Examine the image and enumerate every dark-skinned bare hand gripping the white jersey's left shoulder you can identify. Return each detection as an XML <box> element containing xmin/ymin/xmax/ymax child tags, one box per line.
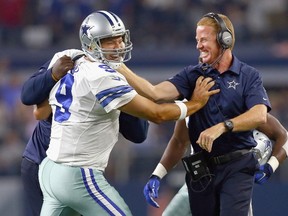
<box><xmin>52</xmin><ymin>55</ymin><xmax>74</xmax><ymax>80</ymax></box>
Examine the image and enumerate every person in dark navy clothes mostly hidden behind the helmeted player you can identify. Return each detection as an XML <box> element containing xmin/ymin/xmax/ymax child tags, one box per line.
<box><xmin>21</xmin><ymin>49</ymin><xmax>149</xmax><ymax>216</ymax></box>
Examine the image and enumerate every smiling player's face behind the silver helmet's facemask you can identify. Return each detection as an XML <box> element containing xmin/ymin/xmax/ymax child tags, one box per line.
<box><xmin>101</xmin><ymin>36</ymin><xmax>125</xmax><ymax>61</ymax></box>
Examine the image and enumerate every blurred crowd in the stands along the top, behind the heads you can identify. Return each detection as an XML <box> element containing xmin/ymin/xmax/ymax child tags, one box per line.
<box><xmin>0</xmin><ymin>0</ymin><xmax>288</xmax><ymax>48</ymax></box>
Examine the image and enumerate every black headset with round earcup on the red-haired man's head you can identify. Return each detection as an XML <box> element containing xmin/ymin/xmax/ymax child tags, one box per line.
<box><xmin>204</xmin><ymin>12</ymin><xmax>233</xmax><ymax>49</ymax></box>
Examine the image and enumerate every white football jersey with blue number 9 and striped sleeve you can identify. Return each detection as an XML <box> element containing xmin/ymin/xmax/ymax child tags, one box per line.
<box><xmin>47</xmin><ymin>52</ymin><xmax>137</xmax><ymax>170</ymax></box>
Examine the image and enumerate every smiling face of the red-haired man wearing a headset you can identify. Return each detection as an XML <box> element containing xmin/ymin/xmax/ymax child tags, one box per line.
<box><xmin>196</xmin><ymin>26</ymin><xmax>221</xmax><ymax>64</ymax></box>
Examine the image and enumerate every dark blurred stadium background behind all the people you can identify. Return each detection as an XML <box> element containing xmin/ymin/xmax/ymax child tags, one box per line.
<box><xmin>0</xmin><ymin>0</ymin><xmax>288</xmax><ymax>216</ymax></box>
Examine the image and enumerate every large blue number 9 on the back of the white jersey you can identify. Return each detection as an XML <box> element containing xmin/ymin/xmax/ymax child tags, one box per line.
<box><xmin>54</xmin><ymin>73</ymin><xmax>74</xmax><ymax>122</ymax></box>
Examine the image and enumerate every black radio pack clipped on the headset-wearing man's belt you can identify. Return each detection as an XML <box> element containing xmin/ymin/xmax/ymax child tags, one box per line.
<box><xmin>182</xmin><ymin>152</ymin><xmax>213</xmax><ymax>192</ymax></box>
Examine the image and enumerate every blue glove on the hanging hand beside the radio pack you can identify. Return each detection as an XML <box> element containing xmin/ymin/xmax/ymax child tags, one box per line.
<box><xmin>143</xmin><ymin>175</ymin><xmax>160</xmax><ymax>208</ymax></box>
